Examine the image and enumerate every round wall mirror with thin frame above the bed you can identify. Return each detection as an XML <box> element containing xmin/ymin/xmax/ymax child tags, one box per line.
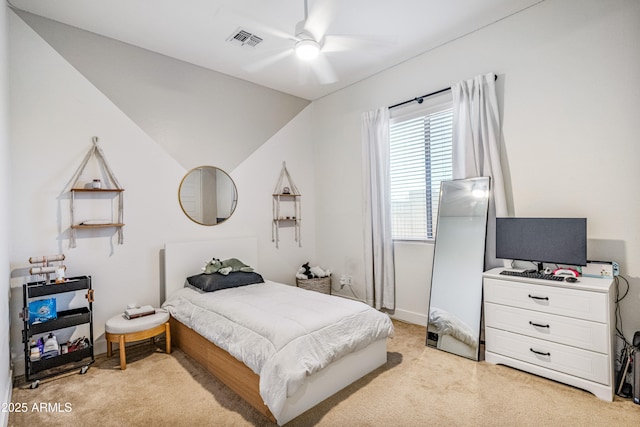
<box><xmin>178</xmin><ymin>166</ymin><xmax>238</xmax><ymax>225</ymax></box>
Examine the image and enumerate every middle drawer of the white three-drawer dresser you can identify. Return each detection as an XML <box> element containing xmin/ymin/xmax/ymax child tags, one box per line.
<box><xmin>484</xmin><ymin>303</ymin><xmax>610</xmax><ymax>354</ymax></box>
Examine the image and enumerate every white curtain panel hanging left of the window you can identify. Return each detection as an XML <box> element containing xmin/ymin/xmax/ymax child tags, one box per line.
<box><xmin>362</xmin><ymin>108</ymin><xmax>395</xmax><ymax>309</ymax></box>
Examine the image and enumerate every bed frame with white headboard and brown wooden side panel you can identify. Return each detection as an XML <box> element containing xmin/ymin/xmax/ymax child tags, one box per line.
<box><xmin>163</xmin><ymin>238</ymin><xmax>387</xmax><ymax>425</ymax></box>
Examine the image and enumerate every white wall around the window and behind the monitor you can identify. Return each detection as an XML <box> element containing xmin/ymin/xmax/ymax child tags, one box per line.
<box><xmin>312</xmin><ymin>0</ymin><xmax>640</xmax><ymax>348</ymax></box>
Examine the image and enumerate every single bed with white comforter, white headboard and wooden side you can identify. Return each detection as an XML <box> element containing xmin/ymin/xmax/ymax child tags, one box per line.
<box><xmin>163</xmin><ymin>237</ymin><xmax>393</xmax><ymax>425</ymax></box>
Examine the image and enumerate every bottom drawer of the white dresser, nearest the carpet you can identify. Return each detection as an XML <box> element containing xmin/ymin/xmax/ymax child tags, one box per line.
<box><xmin>485</xmin><ymin>328</ymin><xmax>611</xmax><ymax>385</ymax></box>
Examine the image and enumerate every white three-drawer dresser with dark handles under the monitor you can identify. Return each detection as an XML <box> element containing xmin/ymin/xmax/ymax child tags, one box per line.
<box><xmin>483</xmin><ymin>268</ymin><xmax>615</xmax><ymax>401</ymax></box>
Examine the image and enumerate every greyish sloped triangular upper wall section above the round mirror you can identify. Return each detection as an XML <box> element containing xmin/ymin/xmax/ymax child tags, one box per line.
<box><xmin>17</xmin><ymin>11</ymin><xmax>309</xmax><ymax>171</ymax></box>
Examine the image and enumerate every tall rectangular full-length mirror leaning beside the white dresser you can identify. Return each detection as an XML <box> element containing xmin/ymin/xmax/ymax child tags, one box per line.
<box><xmin>427</xmin><ymin>177</ymin><xmax>489</xmax><ymax>360</ymax></box>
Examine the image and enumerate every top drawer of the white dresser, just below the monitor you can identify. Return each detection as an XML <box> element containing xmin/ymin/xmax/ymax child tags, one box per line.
<box><xmin>484</xmin><ymin>278</ymin><xmax>609</xmax><ymax>323</ymax></box>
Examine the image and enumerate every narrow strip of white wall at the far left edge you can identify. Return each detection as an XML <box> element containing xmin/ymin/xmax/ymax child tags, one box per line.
<box><xmin>0</xmin><ymin>5</ymin><xmax>12</xmax><ymax>426</ymax></box>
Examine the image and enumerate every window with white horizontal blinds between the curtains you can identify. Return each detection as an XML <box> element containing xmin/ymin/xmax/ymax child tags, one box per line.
<box><xmin>389</xmin><ymin>103</ymin><xmax>453</xmax><ymax>240</ymax></box>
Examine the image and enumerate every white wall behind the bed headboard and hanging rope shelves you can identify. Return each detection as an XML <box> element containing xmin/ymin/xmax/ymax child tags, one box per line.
<box><xmin>8</xmin><ymin>12</ymin><xmax>315</xmax><ymax>375</ymax></box>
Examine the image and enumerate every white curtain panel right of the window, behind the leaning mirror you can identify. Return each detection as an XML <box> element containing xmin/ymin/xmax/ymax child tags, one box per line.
<box><xmin>451</xmin><ymin>73</ymin><xmax>507</xmax><ymax>269</ymax></box>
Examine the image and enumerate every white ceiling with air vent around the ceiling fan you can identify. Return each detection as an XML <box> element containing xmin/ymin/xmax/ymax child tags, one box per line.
<box><xmin>10</xmin><ymin>0</ymin><xmax>543</xmax><ymax>100</ymax></box>
